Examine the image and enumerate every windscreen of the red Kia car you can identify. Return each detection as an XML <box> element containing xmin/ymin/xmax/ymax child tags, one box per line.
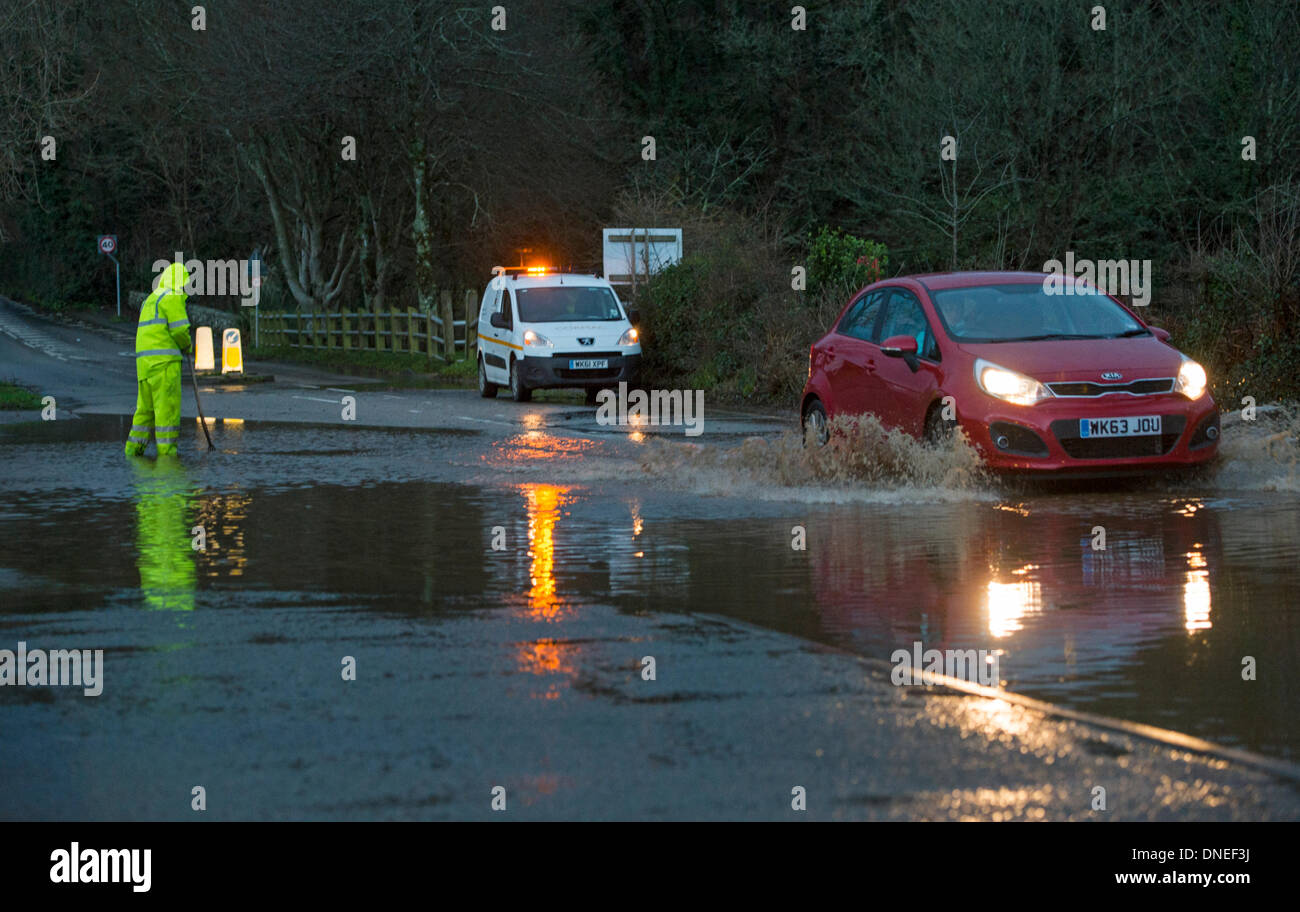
<box><xmin>931</xmin><ymin>282</ymin><xmax>1147</xmax><ymax>342</ymax></box>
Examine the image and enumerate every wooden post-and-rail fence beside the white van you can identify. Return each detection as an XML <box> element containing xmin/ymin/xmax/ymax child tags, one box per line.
<box><xmin>260</xmin><ymin>291</ymin><xmax>478</xmax><ymax>362</ymax></box>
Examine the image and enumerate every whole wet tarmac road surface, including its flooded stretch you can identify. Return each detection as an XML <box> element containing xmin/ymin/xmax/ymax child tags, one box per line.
<box><xmin>0</xmin><ymin>300</ymin><xmax>1300</xmax><ymax>820</ymax></box>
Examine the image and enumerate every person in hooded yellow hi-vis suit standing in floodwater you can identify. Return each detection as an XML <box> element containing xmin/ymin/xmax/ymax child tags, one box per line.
<box><xmin>126</xmin><ymin>262</ymin><xmax>190</xmax><ymax>456</ymax></box>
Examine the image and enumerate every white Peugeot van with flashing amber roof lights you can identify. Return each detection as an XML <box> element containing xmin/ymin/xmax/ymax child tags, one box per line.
<box><xmin>478</xmin><ymin>268</ymin><xmax>641</xmax><ymax>403</ymax></box>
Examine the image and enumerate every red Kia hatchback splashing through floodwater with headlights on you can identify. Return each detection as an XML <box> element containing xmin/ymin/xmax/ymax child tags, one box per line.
<box><xmin>800</xmin><ymin>273</ymin><xmax>1219</xmax><ymax>475</ymax></box>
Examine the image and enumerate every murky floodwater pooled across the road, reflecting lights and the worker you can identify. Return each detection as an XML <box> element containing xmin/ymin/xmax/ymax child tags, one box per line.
<box><xmin>0</xmin><ymin>417</ymin><xmax>1300</xmax><ymax>774</ymax></box>
